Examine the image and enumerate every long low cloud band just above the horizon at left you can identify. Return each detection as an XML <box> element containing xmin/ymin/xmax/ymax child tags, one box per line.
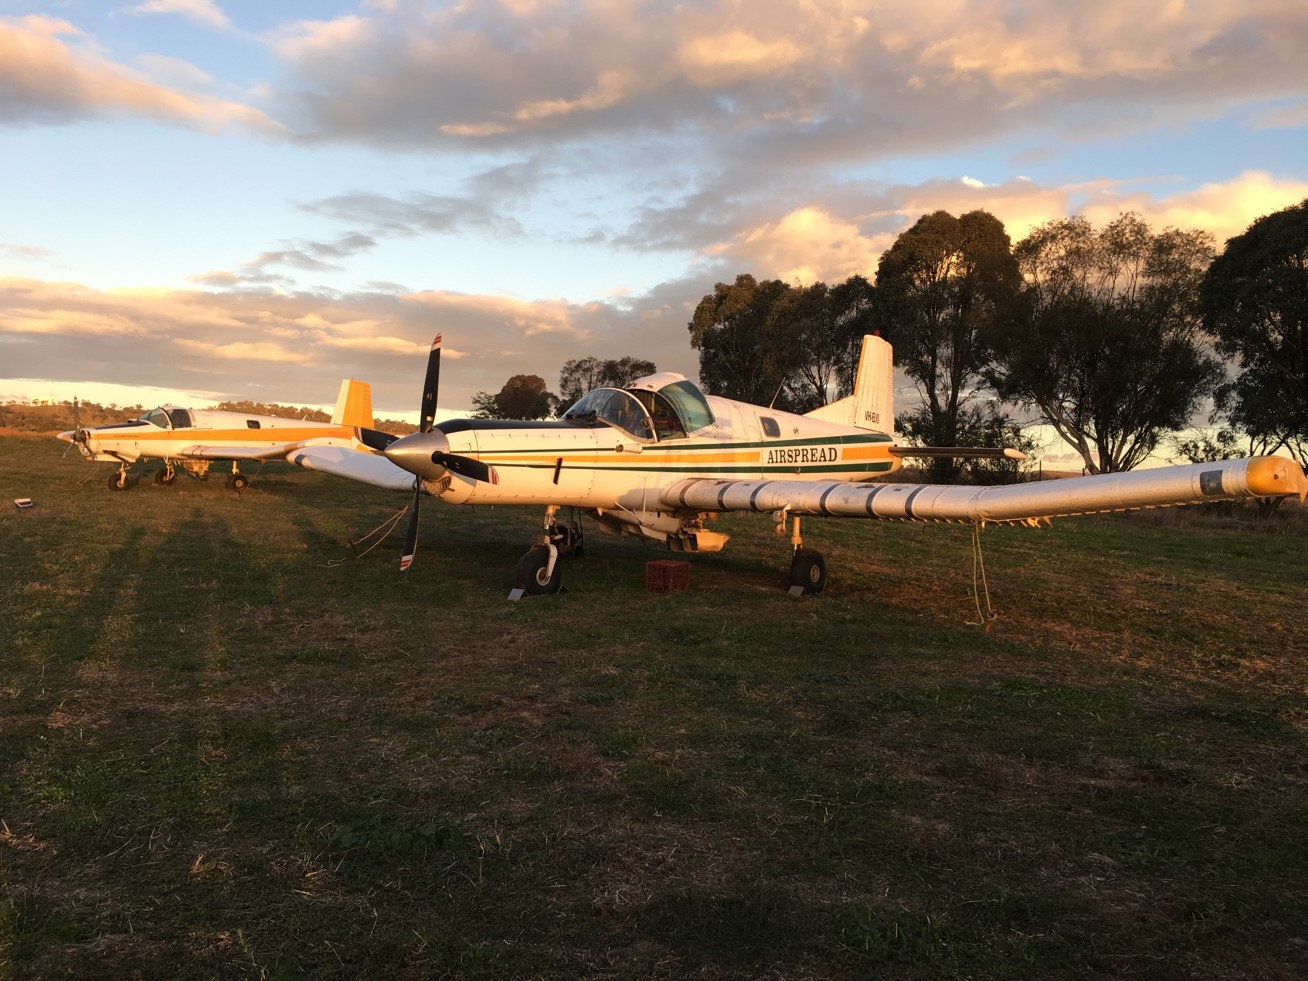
<box><xmin>0</xmin><ymin>277</ymin><xmax>664</xmax><ymax>413</ymax></box>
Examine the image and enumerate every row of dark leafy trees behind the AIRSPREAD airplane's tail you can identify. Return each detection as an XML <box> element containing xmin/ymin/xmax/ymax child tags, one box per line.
<box><xmin>688</xmin><ymin>201</ymin><xmax>1308</xmax><ymax>480</ymax></box>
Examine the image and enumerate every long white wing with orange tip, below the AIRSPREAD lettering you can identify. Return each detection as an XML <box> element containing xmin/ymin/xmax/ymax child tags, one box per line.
<box><xmin>659</xmin><ymin>456</ymin><xmax>1308</xmax><ymax>525</ymax></box>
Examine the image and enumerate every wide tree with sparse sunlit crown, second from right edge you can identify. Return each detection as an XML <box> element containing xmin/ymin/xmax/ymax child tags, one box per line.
<box><xmin>988</xmin><ymin>213</ymin><xmax>1222</xmax><ymax>473</ymax></box>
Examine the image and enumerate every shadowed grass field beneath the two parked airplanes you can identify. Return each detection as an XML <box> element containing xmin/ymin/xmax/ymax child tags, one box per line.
<box><xmin>0</xmin><ymin>437</ymin><xmax>1308</xmax><ymax>978</ymax></box>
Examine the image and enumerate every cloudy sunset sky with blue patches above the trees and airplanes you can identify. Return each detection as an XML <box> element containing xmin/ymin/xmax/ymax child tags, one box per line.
<box><xmin>0</xmin><ymin>0</ymin><xmax>1308</xmax><ymax>449</ymax></box>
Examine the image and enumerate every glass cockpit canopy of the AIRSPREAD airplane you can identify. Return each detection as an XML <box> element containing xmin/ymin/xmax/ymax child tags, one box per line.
<box><xmin>562</xmin><ymin>371</ymin><xmax>713</xmax><ymax>439</ymax></box>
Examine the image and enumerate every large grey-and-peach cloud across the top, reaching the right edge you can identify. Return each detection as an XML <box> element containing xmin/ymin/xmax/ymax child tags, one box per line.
<box><xmin>262</xmin><ymin>0</ymin><xmax>1308</xmax><ymax>162</ymax></box>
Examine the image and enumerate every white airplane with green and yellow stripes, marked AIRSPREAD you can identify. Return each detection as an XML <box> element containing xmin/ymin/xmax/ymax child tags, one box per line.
<box><xmin>289</xmin><ymin>335</ymin><xmax>1308</xmax><ymax>594</ymax></box>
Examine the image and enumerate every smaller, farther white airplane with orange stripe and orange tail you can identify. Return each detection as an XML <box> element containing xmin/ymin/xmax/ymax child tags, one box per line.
<box><xmin>59</xmin><ymin>378</ymin><xmax>387</xmax><ymax>491</ymax></box>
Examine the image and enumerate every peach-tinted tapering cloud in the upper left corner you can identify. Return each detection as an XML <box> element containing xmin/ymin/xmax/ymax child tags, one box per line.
<box><xmin>0</xmin><ymin>14</ymin><xmax>284</xmax><ymax>136</ymax></box>
